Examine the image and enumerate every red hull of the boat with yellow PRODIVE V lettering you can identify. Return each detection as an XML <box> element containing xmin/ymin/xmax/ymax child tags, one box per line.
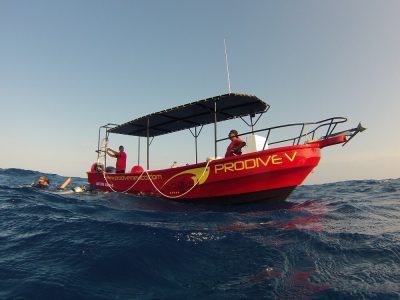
<box><xmin>88</xmin><ymin>142</ymin><xmax>322</xmax><ymax>204</ymax></box>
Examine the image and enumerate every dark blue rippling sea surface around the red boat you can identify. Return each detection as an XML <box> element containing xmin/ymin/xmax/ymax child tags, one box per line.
<box><xmin>0</xmin><ymin>169</ymin><xmax>400</xmax><ymax>299</ymax></box>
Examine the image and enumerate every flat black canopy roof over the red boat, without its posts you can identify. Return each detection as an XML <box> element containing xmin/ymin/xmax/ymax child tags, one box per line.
<box><xmin>110</xmin><ymin>94</ymin><xmax>269</xmax><ymax>137</ymax></box>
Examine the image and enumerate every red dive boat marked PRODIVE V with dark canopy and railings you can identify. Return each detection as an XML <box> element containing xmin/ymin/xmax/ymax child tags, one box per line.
<box><xmin>87</xmin><ymin>94</ymin><xmax>365</xmax><ymax>204</ymax></box>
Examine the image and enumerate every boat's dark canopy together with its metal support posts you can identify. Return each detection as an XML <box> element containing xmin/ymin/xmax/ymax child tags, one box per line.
<box><xmin>96</xmin><ymin>94</ymin><xmax>270</xmax><ymax>169</ymax></box>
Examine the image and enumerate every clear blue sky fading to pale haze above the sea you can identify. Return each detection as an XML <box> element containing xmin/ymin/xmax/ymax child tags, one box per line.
<box><xmin>0</xmin><ymin>0</ymin><xmax>400</xmax><ymax>184</ymax></box>
